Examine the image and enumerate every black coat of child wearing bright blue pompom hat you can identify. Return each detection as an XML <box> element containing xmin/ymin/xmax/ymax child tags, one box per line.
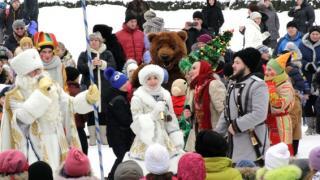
<box><xmin>105</xmin><ymin>88</ymin><xmax>134</xmax><ymax>147</ymax></box>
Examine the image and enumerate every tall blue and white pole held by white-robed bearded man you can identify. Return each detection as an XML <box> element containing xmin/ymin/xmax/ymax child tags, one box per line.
<box><xmin>81</xmin><ymin>0</ymin><xmax>104</xmax><ymax>179</ymax></box>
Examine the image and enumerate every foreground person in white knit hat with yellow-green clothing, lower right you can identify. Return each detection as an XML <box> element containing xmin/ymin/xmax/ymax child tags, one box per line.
<box><xmin>256</xmin><ymin>143</ymin><xmax>302</xmax><ymax>180</ymax></box>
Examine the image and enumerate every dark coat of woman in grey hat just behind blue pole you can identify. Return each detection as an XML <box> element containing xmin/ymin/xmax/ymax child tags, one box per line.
<box><xmin>77</xmin><ymin>50</ymin><xmax>116</xmax><ymax>110</ymax></box>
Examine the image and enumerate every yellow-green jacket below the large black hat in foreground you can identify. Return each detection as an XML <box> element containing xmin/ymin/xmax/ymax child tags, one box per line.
<box><xmin>204</xmin><ymin>157</ymin><xmax>242</xmax><ymax>180</ymax></box>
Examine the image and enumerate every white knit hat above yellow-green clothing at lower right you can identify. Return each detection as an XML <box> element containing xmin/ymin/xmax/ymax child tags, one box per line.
<box><xmin>265</xmin><ymin>142</ymin><xmax>290</xmax><ymax>170</ymax></box>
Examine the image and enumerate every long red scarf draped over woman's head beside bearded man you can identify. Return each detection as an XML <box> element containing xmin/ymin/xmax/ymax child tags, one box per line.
<box><xmin>190</xmin><ymin>61</ymin><xmax>215</xmax><ymax>129</ymax></box>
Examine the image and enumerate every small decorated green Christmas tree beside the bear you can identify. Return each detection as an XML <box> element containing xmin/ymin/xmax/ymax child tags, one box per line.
<box><xmin>179</xmin><ymin>30</ymin><xmax>233</xmax><ymax>72</ymax></box>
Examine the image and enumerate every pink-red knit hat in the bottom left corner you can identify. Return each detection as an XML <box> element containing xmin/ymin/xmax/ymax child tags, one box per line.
<box><xmin>0</xmin><ymin>150</ymin><xmax>29</xmax><ymax>174</ymax></box>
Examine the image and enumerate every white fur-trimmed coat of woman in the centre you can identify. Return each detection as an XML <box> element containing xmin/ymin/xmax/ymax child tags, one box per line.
<box><xmin>130</xmin><ymin>87</ymin><xmax>184</xmax><ymax>159</ymax></box>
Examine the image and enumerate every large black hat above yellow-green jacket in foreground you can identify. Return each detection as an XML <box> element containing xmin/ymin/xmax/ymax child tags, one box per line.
<box><xmin>195</xmin><ymin>130</ymin><xmax>228</xmax><ymax>158</ymax></box>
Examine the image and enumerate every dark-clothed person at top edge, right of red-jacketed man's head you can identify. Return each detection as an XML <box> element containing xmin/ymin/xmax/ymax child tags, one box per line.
<box><xmin>125</xmin><ymin>0</ymin><xmax>150</xmax><ymax>31</ymax></box>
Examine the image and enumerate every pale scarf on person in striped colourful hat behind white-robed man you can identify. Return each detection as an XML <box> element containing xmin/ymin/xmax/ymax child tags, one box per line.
<box><xmin>43</xmin><ymin>56</ymin><xmax>64</xmax><ymax>88</ymax></box>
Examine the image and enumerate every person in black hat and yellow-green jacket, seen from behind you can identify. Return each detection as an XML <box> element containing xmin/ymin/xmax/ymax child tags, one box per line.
<box><xmin>195</xmin><ymin>130</ymin><xmax>242</xmax><ymax>180</ymax></box>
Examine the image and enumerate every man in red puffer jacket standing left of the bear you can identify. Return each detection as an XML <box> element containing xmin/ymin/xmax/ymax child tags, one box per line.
<box><xmin>116</xmin><ymin>14</ymin><xmax>145</xmax><ymax>65</ymax></box>
